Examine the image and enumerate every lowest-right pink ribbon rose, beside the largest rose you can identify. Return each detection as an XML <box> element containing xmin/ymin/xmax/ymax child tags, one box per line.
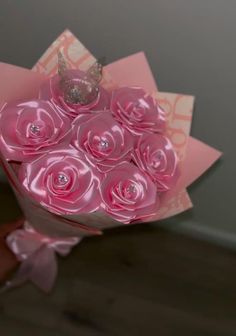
<box><xmin>100</xmin><ymin>162</ymin><xmax>159</xmax><ymax>224</ymax></box>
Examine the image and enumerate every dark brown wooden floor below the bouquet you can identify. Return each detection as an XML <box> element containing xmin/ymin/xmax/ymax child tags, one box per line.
<box><xmin>0</xmin><ymin>182</ymin><xmax>236</xmax><ymax>336</ymax></box>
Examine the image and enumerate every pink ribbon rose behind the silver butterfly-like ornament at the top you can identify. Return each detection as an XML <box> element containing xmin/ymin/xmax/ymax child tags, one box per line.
<box><xmin>39</xmin><ymin>70</ymin><xmax>110</xmax><ymax>118</ymax></box>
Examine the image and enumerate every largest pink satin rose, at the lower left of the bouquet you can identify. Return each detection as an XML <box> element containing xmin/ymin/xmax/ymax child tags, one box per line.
<box><xmin>19</xmin><ymin>147</ymin><xmax>101</xmax><ymax>214</ymax></box>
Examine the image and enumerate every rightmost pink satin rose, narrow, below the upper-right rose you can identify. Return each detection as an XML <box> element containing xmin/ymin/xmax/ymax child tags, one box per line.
<box><xmin>132</xmin><ymin>134</ymin><xmax>179</xmax><ymax>192</ymax></box>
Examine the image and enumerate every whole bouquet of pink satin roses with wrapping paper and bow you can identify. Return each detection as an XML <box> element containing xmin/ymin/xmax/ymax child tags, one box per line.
<box><xmin>0</xmin><ymin>31</ymin><xmax>221</xmax><ymax>291</ymax></box>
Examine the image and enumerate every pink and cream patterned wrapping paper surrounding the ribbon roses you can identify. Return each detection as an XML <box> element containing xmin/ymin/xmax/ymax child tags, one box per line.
<box><xmin>0</xmin><ymin>30</ymin><xmax>221</xmax><ymax>284</ymax></box>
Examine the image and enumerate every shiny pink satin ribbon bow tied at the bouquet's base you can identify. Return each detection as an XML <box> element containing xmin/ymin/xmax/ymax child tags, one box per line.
<box><xmin>2</xmin><ymin>222</ymin><xmax>82</xmax><ymax>292</ymax></box>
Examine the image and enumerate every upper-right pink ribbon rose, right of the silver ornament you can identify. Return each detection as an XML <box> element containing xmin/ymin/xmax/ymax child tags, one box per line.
<box><xmin>111</xmin><ymin>87</ymin><xmax>165</xmax><ymax>134</ymax></box>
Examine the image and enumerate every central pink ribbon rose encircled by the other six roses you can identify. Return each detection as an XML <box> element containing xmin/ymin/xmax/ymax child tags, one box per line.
<box><xmin>72</xmin><ymin>112</ymin><xmax>133</xmax><ymax>172</ymax></box>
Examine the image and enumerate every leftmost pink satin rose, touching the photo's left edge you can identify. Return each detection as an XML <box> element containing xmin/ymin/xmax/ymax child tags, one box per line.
<box><xmin>0</xmin><ymin>100</ymin><xmax>71</xmax><ymax>162</ymax></box>
